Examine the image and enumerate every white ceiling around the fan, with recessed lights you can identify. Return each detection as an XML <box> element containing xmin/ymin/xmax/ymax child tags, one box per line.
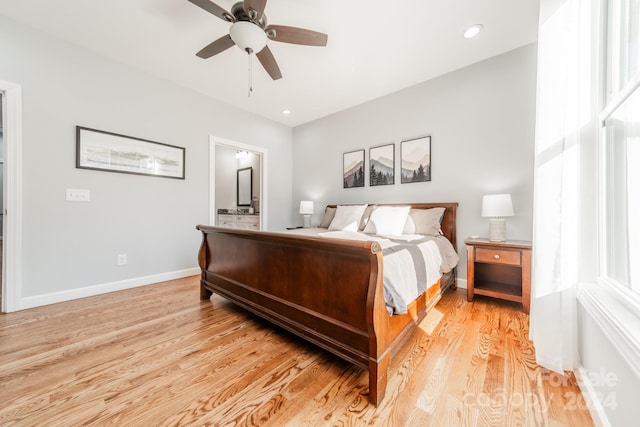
<box><xmin>0</xmin><ymin>0</ymin><xmax>538</xmax><ymax>126</ymax></box>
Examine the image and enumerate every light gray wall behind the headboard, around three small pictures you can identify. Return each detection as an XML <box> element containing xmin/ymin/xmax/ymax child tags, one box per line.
<box><xmin>293</xmin><ymin>45</ymin><xmax>536</xmax><ymax>285</ymax></box>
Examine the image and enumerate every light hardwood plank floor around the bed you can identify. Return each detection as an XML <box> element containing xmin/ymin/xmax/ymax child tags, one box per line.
<box><xmin>0</xmin><ymin>277</ymin><xmax>593</xmax><ymax>426</ymax></box>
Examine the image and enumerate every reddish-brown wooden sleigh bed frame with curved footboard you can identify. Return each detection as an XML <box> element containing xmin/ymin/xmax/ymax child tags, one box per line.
<box><xmin>196</xmin><ymin>203</ymin><xmax>458</xmax><ymax>405</ymax></box>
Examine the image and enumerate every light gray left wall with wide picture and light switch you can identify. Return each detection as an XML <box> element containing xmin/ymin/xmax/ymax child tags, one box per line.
<box><xmin>0</xmin><ymin>17</ymin><xmax>292</xmax><ymax>297</ymax></box>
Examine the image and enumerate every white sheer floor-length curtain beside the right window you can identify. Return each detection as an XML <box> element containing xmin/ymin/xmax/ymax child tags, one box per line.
<box><xmin>530</xmin><ymin>0</ymin><xmax>596</xmax><ymax>373</ymax></box>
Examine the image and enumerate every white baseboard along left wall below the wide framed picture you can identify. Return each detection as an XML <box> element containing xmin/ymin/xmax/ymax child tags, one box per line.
<box><xmin>20</xmin><ymin>267</ymin><xmax>200</xmax><ymax>310</ymax></box>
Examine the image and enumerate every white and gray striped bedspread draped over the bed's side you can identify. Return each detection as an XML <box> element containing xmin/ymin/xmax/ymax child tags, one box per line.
<box><xmin>293</xmin><ymin>228</ymin><xmax>459</xmax><ymax>314</ymax></box>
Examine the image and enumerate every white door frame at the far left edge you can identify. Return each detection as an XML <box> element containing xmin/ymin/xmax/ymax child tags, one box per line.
<box><xmin>0</xmin><ymin>80</ymin><xmax>22</xmax><ymax>313</ymax></box>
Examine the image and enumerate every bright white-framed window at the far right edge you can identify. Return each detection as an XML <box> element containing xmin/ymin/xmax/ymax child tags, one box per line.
<box><xmin>600</xmin><ymin>0</ymin><xmax>640</xmax><ymax>294</ymax></box>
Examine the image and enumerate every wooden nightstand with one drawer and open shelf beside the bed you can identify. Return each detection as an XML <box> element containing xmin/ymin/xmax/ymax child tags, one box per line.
<box><xmin>464</xmin><ymin>239</ymin><xmax>531</xmax><ymax>314</ymax></box>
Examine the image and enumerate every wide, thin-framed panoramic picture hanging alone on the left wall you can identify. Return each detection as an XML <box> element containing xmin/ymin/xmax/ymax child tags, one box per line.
<box><xmin>76</xmin><ymin>126</ymin><xmax>185</xmax><ymax>179</ymax></box>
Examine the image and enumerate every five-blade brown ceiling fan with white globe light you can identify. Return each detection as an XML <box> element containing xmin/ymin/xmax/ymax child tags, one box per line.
<box><xmin>189</xmin><ymin>0</ymin><xmax>327</xmax><ymax>80</ymax></box>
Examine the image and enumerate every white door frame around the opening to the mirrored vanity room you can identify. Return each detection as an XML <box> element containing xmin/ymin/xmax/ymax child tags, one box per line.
<box><xmin>209</xmin><ymin>135</ymin><xmax>269</xmax><ymax>230</ymax></box>
